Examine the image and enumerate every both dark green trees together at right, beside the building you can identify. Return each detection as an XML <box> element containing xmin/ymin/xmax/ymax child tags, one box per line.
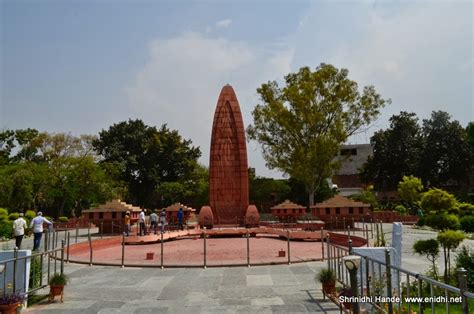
<box><xmin>361</xmin><ymin>111</ymin><xmax>474</xmax><ymax>191</ymax></box>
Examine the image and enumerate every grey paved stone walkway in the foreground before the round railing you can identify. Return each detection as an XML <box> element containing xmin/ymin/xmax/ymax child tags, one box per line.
<box><xmin>24</xmin><ymin>262</ymin><xmax>339</xmax><ymax>313</ymax></box>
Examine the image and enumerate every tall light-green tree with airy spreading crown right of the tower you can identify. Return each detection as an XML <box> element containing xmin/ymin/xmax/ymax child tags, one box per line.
<box><xmin>247</xmin><ymin>64</ymin><xmax>387</xmax><ymax>205</ymax></box>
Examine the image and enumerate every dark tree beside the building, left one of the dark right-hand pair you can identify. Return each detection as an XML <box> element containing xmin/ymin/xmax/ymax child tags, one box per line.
<box><xmin>362</xmin><ymin>111</ymin><xmax>423</xmax><ymax>191</ymax></box>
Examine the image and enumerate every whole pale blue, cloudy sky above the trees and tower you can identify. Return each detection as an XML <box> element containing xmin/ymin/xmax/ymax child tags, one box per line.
<box><xmin>0</xmin><ymin>0</ymin><xmax>474</xmax><ymax>177</ymax></box>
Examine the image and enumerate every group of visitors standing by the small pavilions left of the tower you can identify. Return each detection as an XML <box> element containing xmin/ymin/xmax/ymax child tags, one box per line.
<box><xmin>132</xmin><ymin>208</ymin><xmax>184</xmax><ymax>236</ymax></box>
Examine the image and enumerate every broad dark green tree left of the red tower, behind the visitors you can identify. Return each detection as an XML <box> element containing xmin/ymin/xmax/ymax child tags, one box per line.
<box><xmin>93</xmin><ymin>120</ymin><xmax>201</xmax><ymax>207</ymax></box>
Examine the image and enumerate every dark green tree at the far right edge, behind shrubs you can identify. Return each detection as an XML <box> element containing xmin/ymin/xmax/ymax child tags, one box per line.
<box><xmin>420</xmin><ymin>111</ymin><xmax>474</xmax><ymax>187</ymax></box>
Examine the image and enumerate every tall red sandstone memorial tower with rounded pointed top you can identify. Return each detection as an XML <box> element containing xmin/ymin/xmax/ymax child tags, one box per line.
<box><xmin>209</xmin><ymin>85</ymin><xmax>249</xmax><ymax>224</ymax></box>
